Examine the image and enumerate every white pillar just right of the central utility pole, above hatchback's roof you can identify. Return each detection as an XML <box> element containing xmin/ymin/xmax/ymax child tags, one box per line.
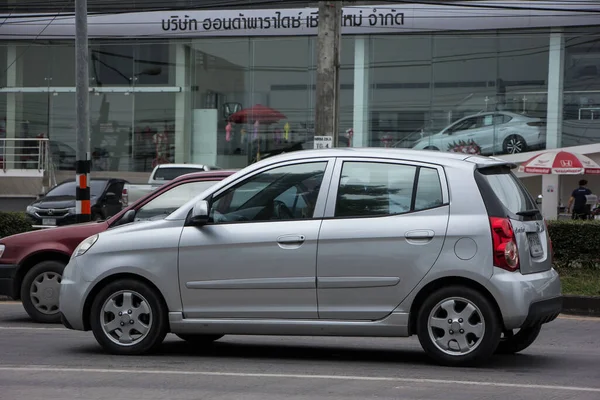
<box><xmin>352</xmin><ymin>36</ymin><xmax>371</xmax><ymax>147</ymax></box>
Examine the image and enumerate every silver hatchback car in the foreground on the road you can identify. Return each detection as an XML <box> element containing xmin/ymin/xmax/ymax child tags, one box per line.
<box><xmin>60</xmin><ymin>148</ymin><xmax>562</xmax><ymax>365</ymax></box>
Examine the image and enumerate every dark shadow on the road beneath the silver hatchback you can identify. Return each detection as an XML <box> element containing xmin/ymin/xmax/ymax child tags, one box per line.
<box><xmin>68</xmin><ymin>336</ymin><xmax>562</xmax><ymax>371</ymax></box>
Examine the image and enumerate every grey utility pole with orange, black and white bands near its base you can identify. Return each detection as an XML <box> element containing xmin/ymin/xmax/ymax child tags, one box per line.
<box><xmin>75</xmin><ymin>0</ymin><xmax>92</xmax><ymax>223</ymax></box>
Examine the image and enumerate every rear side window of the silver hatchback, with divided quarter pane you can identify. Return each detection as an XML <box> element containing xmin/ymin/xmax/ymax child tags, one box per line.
<box><xmin>335</xmin><ymin>162</ymin><xmax>443</xmax><ymax>218</ymax></box>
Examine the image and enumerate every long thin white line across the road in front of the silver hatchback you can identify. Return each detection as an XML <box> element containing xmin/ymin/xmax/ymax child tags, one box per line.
<box><xmin>0</xmin><ymin>366</ymin><xmax>600</xmax><ymax>393</ymax></box>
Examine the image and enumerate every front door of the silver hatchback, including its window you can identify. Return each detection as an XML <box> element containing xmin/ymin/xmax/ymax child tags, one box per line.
<box><xmin>179</xmin><ymin>159</ymin><xmax>333</xmax><ymax>319</ymax></box>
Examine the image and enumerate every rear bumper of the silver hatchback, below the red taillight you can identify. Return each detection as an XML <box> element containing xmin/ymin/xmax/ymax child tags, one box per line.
<box><xmin>488</xmin><ymin>269</ymin><xmax>562</xmax><ymax>329</ymax></box>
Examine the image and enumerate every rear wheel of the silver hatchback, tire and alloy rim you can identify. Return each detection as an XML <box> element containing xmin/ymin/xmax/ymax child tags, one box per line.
<box><xmin>417</xmin><ymin>286</ymin><xmax>501</xmax><ymax>366</ymax></box>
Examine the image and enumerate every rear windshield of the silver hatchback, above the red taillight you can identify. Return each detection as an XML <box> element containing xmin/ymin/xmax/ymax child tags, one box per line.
<box><xmin>479</xmin><ymin>168</ymin><xmax>537</xmax><ymax>214</ymax></box>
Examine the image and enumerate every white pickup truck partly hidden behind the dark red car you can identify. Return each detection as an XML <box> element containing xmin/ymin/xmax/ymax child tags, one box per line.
<box><xmin>122</xmin><ymin>164</ymin><xmax>221</xmax><ymax>206</ymax></box>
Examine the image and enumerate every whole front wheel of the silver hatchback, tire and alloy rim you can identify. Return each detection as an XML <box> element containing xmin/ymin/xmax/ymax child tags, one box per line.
<box><xmin>90</xmin><ymin>279</ymin><xmax>168</xmax><ymax>355</ymax></box>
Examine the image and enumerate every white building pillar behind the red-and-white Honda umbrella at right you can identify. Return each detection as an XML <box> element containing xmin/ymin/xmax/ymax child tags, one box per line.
<box><xmin>542</xmin><ymin>28</ymin><xmax>565</xmax><ymax>219</ymax></box>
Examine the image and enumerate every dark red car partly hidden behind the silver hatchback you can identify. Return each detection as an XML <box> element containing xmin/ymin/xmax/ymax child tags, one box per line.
<box><xmin>0</xmin><ymin>170</ymin><xmax>233</xmax><ymax>323</ymax></box>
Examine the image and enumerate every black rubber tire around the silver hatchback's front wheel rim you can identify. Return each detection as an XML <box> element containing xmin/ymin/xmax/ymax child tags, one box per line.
<box><xmin>90</xmin><ymin>279</ymin><xmax>169</xmax><ymax>355</ymax></box>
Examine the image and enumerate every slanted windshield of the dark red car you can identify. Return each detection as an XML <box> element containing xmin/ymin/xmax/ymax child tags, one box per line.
<box><xmin>135</xmin><ymin>181</ymin><xmax>218</xmax><ymax>221</ymax></box>
